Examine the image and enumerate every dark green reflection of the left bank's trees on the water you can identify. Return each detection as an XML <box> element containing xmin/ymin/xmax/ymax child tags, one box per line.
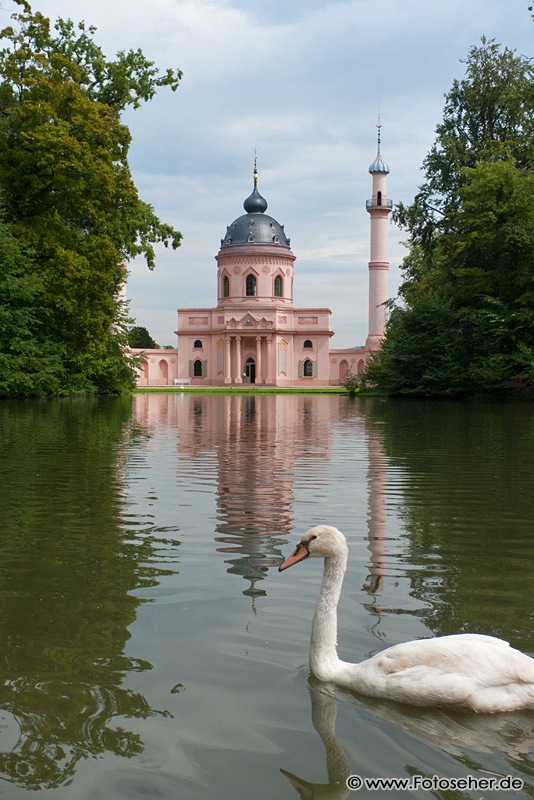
<box><xmin>0</xmin><ymin>398</ymin><xmax>170</xmax><ymax>789</ymax></box>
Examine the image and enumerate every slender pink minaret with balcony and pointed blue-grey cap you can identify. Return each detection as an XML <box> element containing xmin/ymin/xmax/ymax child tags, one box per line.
<box><xmin>365</xmin><ymin>118</ymin><xmax>393</xmax><ymax>350</ymax></box>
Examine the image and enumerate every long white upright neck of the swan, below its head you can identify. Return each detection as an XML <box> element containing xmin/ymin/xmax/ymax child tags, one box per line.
<box><xmin>310</xmin><ymin>553</ymin><xmax>347</xmax><ymax>681</ymax></box>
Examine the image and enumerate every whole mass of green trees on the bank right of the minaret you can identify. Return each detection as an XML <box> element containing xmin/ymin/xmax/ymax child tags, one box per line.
<box><xmin>365</xmin><ymin>39</ymin><xmax>534</xmax><ymax>396</ymax></box>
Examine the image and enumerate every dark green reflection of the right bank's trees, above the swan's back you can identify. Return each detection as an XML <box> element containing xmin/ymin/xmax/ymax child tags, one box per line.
<box><xmin>362</xmin><ymin>400</ymin><xmax>534</xmax><ymax>649</ymax></box>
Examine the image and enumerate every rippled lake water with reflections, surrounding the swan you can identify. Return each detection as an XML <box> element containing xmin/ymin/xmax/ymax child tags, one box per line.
<box><xmin>0</xmin><ymin>393</ymin><xmax>534</xmax><ymax>800</ymax></box>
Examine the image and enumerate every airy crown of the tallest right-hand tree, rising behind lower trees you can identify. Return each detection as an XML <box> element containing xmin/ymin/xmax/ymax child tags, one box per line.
<box><xmin>394</xmin><ymin>37</ymin><xmax>534</xmax><ymax>256</ymax></box>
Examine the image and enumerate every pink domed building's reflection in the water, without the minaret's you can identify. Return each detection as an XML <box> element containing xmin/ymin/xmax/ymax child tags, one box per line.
<box><xmin>134</xmin><ymin>392</ymin><xmax>340</xmax><ymax>597</ymax></box>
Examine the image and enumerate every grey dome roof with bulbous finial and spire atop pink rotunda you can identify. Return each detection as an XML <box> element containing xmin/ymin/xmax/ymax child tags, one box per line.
<box><xmin>221</xmin><ymin>170</ymin><xmax>290</xmax><ymax>248</ymax></box>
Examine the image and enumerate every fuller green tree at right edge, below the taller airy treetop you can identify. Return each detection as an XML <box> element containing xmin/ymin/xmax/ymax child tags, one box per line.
<box><xmin>440</xmin><ymin>160</ymin><xmax>534</xmax><ymax>390</ymax></box>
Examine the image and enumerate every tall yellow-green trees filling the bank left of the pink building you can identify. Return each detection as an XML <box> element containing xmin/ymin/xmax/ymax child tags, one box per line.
<box><xmin>0</xmin><ymin>0</ymin><xmax>181</xmax><ymax>396</ymax></box>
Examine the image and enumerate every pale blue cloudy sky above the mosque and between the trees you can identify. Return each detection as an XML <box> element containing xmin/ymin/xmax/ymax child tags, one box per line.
<box><xmin>10</xmin><ymin>0</ymin><xmax>534</xmax><ymax>348</ymax></box>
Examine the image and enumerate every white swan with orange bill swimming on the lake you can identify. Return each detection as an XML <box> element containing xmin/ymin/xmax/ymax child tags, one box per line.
<box><xmin>279</xmin><ymin>525</ymin><xmax>534</xmax><ymax>712</ymax></box>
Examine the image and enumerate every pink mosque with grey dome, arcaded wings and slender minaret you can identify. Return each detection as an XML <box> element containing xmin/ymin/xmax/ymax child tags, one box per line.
<box><xmin>134</xmin><ymin>130</ymin><xmax>393</xmax><ymax>388</ymax></box>
